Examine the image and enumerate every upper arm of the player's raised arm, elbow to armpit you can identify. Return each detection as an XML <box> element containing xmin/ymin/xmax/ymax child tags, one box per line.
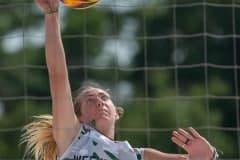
<box><xmin>49</xmin><ymin>72</ymin><xmax>80</xmax><ymax>155</ymax></box>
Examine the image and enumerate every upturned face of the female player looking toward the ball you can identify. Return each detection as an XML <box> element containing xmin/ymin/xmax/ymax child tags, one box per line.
<box><xmin>79</xmin><ymin>88</ymin><xmax>119</xmax><ymax>125</ymax></box>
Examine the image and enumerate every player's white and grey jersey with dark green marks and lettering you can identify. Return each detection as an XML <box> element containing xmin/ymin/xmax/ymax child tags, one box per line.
<box><xmin>58</xmin><ymin>124</ymin><xmax>143</xmax><ymax>160</ymax></box>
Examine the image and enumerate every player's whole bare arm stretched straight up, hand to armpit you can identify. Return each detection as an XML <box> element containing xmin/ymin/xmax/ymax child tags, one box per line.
<box><xmin>36</xmin><ymin>0</ymin><xmax>80</xmax><ymax>155</ymax></box>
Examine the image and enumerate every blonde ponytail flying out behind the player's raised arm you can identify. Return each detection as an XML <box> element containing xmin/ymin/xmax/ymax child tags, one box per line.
<box><xmin>20</xmin><ymin>115</ymin><xmax>57</xmax><ymax>160</ymax></box>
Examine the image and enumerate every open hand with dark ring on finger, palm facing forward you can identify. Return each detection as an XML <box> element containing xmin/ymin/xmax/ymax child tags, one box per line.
<box><xmin>171</xmin><ymin>127</ymin><xmax>214</xmax><ymax>160</ymax></box>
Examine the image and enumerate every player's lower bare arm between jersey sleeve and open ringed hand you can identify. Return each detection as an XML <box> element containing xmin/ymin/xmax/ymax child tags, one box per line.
<box><xmin>144</xmin><ymin>148</ymin><xmax>188</xmax><ymax>160</ymax></box>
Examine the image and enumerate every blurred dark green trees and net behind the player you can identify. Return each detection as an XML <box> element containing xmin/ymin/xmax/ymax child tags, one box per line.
<box><xmin>0</xmin><ymin>0</ymin><xmax>240</xmax><ymax>160</ymax></box>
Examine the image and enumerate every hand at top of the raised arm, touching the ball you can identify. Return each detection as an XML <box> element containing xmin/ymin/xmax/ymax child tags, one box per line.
<box><xmin>35</xmin><ymin>0</ymin><xmax>59</xmax><ymax>14</ymax></box>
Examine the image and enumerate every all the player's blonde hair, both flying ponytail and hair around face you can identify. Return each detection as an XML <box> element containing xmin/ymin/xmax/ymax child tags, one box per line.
<box><xmin>20</xmin><ymin>85</ymin><xmax>124</xmax><ymax>160</ymax></box>
